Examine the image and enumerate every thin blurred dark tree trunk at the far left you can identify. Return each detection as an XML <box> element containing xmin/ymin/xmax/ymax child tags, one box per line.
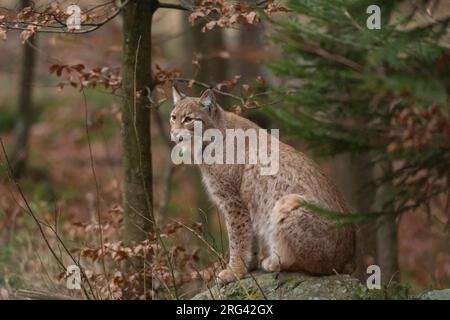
<box><xmin>11</xmin><ymin>0</ymin><xmax>37</xmax><ymax>178</ymax></box>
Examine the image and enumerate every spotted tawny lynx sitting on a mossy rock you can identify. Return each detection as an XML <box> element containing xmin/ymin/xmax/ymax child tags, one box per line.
<box><xmin>170</xmin><ymin>88</ymin><xmax>355</xmax><ymax>283</ymax></box>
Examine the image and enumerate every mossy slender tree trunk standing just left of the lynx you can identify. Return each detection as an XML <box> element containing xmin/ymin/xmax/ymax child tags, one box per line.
<box><xmin>121</xmin><ymin>0</ymin><xmax>157</xmax><ymax>244</ymax></box>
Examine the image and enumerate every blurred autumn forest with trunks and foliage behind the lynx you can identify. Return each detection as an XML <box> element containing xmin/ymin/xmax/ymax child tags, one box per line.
<box><xmin>0</xmin><ymin>0</ymin><xmax>450</xmax><ymax>298</ymax></box>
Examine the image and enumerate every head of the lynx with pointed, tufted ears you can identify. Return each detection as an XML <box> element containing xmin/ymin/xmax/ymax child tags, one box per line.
<box><xmin>170</xmin><ymin>87</ymin><xmax>220</xmax><ymax>141</ymax></box>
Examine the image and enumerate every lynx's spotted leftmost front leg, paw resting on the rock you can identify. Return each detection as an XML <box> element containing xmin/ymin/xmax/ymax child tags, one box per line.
<box><xmin>218</xmin><ymin>199</ymin><xmax>257</xmax><ymax>284</ymax></box>
